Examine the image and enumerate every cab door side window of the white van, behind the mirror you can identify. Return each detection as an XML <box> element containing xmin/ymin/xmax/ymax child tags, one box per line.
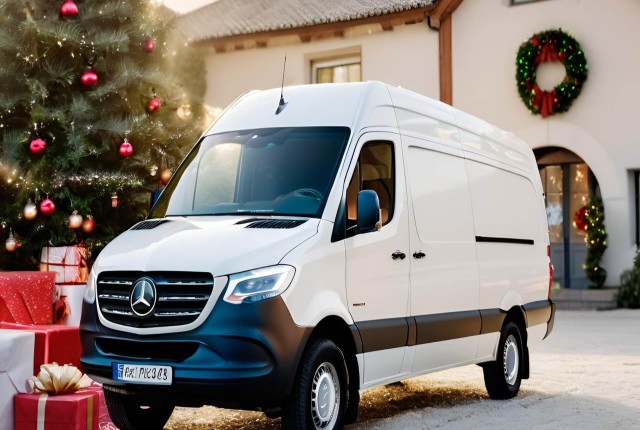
<box><xmin>346</xmin><ymin>141</ymin><xmax>395</xmax><ymax>237</ymax></box>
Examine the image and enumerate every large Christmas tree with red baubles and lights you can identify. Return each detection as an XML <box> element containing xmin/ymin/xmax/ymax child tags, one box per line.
<box><xmin>0</xmin><ymin>0</ymin><xmax>204</xmax><ymax>269</ymax></box>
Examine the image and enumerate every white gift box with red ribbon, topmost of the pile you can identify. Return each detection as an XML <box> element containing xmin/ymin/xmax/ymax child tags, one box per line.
<box><xmin>40</xmin><ymin>246</ymin><xmax>89</xmax><ymax>284</ymax></box>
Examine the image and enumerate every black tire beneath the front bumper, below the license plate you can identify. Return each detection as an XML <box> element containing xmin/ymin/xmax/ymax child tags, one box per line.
<box><xmin>104</xmin><ymin>387</ymin><xmax>174</xmax><ymax>430</ymax></box>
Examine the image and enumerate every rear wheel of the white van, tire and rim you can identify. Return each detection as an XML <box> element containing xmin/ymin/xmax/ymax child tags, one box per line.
<box><xmin>482</xmin><ymin>322</ymin><xmax>526</xmax><ymax>400</ymax></box>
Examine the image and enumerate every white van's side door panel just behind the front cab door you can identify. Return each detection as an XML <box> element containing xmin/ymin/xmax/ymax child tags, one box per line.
<box><xmin>402</xmin><ymin>136</ymin><xmax>481</xmax><ymax>372</ymax></box>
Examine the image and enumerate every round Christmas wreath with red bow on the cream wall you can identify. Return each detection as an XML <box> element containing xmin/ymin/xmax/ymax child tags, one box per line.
<box><xmin>516</xmin><ymin>29</ymin><xmax>587</xmax><ymax>118</ymax></box>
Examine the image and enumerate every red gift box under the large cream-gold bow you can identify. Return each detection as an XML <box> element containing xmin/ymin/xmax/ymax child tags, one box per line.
<box><xmin>13</xmin><ymin>390</ymin><xmax>100</xmax><ymax>430</ymax></box>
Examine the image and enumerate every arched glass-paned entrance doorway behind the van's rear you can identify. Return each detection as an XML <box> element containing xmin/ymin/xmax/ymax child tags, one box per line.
<box><xmin>534</xmin><ymin>147</ymin><xmax>598</xmax><ymax>288</ymax></box>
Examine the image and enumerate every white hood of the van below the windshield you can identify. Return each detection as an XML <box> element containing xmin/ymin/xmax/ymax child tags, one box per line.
<box><xmin>94</xmin><ymin>216</ymin><xmax>320</xmax><ymax>276</ymax></box>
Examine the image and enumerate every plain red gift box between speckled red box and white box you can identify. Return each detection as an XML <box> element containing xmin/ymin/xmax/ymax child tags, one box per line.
<box><xmin>0</xmin><ymin>322</ymin><xmax>82</xmax><ymax>375</ymax></box>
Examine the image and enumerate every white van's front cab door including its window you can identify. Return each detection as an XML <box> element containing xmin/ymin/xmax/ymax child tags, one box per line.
<box><xmin>345</xmin><ymin>133</ymin><xmax>411</xmax><ymax>386</ymax></box>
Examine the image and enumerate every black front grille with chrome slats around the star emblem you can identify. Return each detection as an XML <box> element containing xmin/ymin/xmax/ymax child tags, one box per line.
<box><xmin>97</xmin><ymin>272</ymin><xmax>213</xmax><ymax>328</ymax></box>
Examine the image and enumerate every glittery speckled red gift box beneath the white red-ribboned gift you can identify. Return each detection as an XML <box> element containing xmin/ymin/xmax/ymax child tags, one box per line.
<box><xmin>0</xmin><ymin>272</ymin><xmax>55</xmax><ymax>324</ymax></box>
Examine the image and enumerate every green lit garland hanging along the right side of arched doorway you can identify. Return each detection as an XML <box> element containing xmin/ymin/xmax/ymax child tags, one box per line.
<box><xmin>584</xmin><ymin>196</ymin><xmax>607</xmax><ymax>288</ymax></box>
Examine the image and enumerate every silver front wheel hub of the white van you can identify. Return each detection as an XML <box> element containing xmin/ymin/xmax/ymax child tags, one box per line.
<box><xmin>311</xmin><ymin>363</ymin><xmax>340</xmax><ymax>429</ymax></box>
